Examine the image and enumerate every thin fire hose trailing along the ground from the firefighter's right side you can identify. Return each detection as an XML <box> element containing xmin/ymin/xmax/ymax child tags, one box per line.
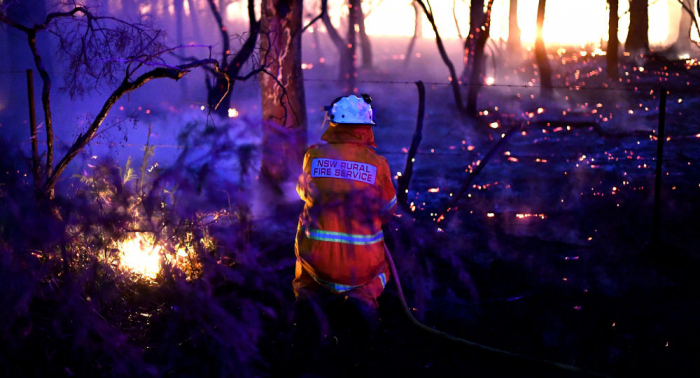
<box><xmin>384</xmin><ymin>244</ymin><xmax>610</xmax><ymax>377</ymax></box>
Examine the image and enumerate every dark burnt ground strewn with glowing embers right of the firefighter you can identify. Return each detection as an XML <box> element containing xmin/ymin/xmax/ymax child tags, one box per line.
<box><xmin>256</xmin><ymin>48</ymin><xmax>700</xmax><ymax>377</ymax></box>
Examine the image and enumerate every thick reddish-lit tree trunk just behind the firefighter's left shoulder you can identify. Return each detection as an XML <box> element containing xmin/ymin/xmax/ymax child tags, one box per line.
<box><xmin>259</xmin><ymin>0</ymin><xmax>307</xmax><ymax>196</ymax></box>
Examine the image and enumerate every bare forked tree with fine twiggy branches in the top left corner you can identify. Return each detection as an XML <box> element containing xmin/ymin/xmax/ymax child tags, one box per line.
<box><xmin>0</xmin><ymin>6</ymin><xmax>226</xmax><ymax>198</ymax></box>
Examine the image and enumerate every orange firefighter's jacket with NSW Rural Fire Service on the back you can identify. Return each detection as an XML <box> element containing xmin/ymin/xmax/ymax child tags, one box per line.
<box><xmin>296</xmin><ymin>123</ymin><xmax>396</xmax><ymax>293</ymax></box>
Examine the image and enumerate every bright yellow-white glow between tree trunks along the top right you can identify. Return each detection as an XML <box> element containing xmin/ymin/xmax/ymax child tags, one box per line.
<box><xmin>364</xmin><ymin>0</ymin><xmax>668</xmax><ymax>45</ymax></box>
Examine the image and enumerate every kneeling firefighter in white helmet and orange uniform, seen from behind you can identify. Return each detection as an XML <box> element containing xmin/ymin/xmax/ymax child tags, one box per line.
<box><xmin>293</xmin><ymin>94</ymin><xmax>396</xmax><ymax>352</ymax></box>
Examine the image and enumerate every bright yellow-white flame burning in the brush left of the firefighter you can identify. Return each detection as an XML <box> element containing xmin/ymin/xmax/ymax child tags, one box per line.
<box><xmin>116</xmin><ymin>232</ymin><xmax>163</xmax><ymax>279</ymax></box>
